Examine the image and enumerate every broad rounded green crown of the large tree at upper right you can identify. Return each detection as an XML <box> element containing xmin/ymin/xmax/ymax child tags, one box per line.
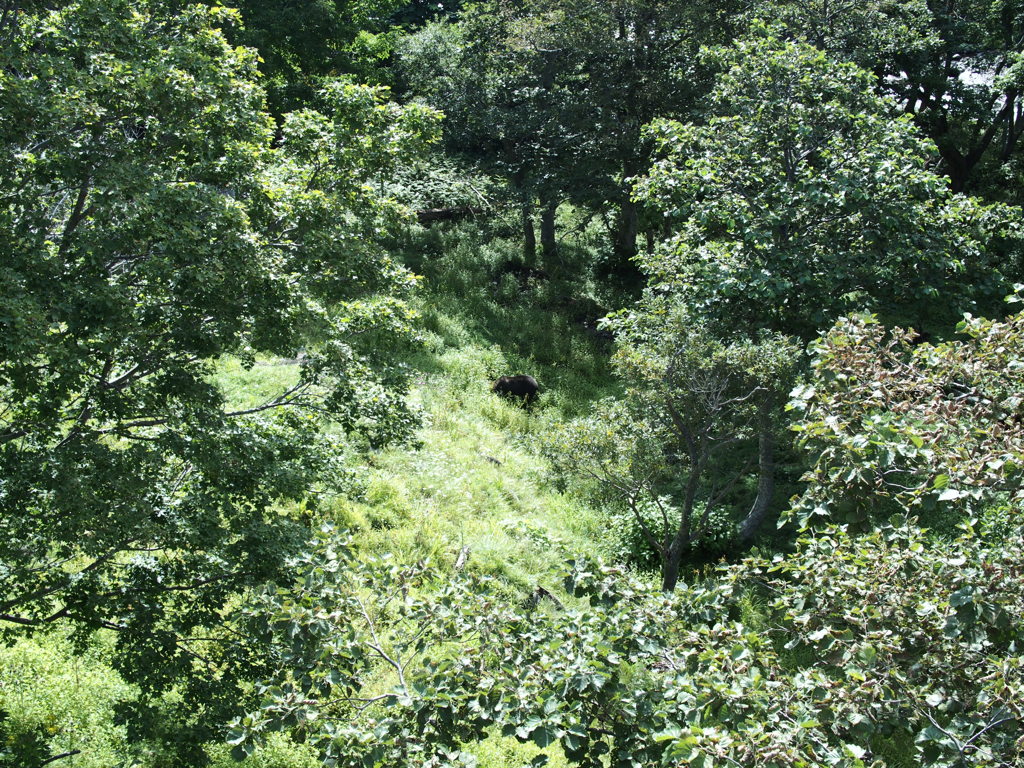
<box><xmin>638</xmin><ymin>30</ymin><xmax>1019</xmax><ymax>341</ymax></box>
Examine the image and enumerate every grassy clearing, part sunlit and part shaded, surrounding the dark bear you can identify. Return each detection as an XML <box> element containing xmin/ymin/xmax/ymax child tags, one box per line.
<box><xmin>319</xmin><ymin>221</ymin><xmax>626</xmax><ymax>590</ymax></box>
